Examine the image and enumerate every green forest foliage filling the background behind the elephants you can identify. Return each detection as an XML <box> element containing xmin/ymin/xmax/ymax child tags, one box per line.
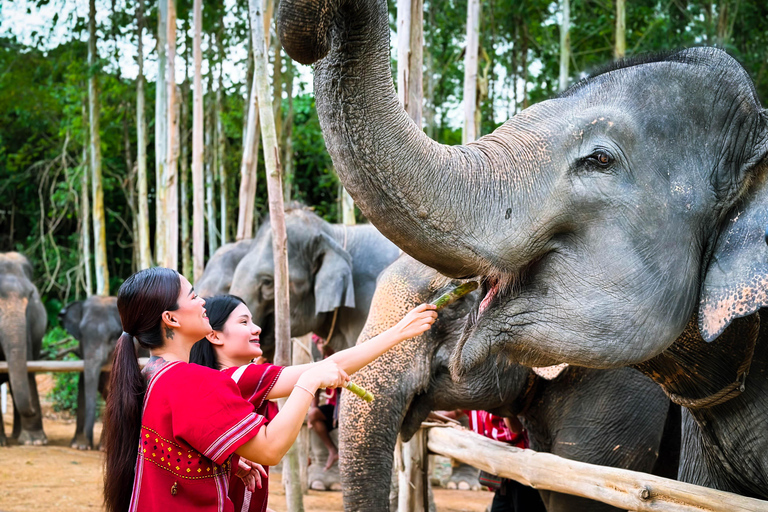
<box><xmin>0</xmin><ymin>0</ymin><xmax>768</xmax><ymax>326</ymax></box>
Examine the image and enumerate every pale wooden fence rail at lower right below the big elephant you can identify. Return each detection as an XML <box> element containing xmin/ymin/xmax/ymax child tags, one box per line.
<box><xmin>427</xmin><ymin>427</ymin><xmax>768</xmax><ymax>512</ymax></box>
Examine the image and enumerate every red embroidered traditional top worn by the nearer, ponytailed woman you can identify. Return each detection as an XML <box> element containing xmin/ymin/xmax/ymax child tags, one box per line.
<box><xmin>129</xmin><ymin>360</ymin><xmax>266</xmax><ymax>512</ymax></box>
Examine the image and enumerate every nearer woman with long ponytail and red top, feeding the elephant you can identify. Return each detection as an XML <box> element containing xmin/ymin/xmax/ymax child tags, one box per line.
<box><xmin>104</xmin><ymin>268</ymin><xmax>436</xmax><ymax>512</ymax></box>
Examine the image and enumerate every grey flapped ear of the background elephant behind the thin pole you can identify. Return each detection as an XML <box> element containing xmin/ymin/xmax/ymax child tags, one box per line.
<box><xmin>315</xmin><ymin>233</ymin><xmax>355</xmax><ymax>314</ymax></box>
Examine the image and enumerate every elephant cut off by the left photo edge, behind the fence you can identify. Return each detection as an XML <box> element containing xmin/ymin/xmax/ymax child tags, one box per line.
<box><xmin>0</xmin><ymin>252</ymin><xmax>48</xmax><ymax>446</ymax></box>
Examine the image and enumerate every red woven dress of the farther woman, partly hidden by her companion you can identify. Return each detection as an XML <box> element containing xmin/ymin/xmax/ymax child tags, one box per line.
<box><xmin>222</xmin><ymin>364</ymin><xmax>283</xmax><ymax>512</ymax></box>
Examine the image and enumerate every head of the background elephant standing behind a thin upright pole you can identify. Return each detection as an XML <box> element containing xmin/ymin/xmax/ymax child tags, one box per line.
<box><xmin>230</xmin><ymin>209</ymin><xmax>355</xmax><ymax>359</ymax></box>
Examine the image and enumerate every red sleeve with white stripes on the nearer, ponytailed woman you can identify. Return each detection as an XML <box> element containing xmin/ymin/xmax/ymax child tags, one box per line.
<box><xmin>172</xmin><ymin>364</ymin><xmax>265</xmax><ymax>464</ymax></box>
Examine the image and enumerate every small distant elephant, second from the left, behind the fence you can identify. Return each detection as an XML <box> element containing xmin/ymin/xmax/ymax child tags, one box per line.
<box><xmin>59</xmin><ymin>295</ymin><xmax>123</xmax><ymax>450</ymax></box>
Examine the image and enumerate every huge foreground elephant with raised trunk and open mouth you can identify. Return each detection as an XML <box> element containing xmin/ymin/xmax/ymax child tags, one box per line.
<box><xmin>278</xmin><ymin>0</ymin><xmax>768</xmax><ymax>499</ymax></box>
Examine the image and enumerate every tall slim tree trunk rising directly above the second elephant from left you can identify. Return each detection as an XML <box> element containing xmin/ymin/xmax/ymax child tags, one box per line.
<box><xmin>88</xmin><ymin>0</ymin><xmax>109</xmax><ymax>296</ymax></box>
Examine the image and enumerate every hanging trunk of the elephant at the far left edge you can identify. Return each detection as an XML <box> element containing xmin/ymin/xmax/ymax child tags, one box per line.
<box><xmin>0</xmin><ymin>297</ymin><xmax>37</xmax><ymax>418</ymax></box>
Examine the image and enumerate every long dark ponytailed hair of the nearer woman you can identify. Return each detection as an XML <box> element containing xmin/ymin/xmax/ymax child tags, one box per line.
<box><xmin>104</xmin><ymin>267</ymin><xmax>181</xmax><ymax>512</ymax></box>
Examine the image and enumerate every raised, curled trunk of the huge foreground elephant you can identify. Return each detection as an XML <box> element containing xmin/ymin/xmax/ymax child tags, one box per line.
<box><xmin>278</xmin><ymin>0</ymin><xmax>543</xmax><ymax>277</ymax></box>
